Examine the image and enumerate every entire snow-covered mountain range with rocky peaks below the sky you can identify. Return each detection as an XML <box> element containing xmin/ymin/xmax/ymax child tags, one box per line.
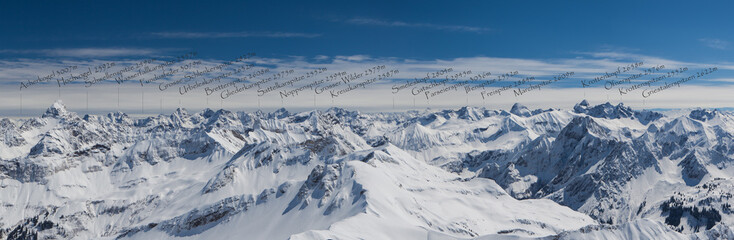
<box><xmin>0</xmin><ymin>101</ymin><xmax>734</xmax><ymax>240</ymax></box>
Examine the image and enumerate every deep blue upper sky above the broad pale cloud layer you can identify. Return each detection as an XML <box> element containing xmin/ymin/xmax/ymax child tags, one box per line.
<box><xmin>0</xmin><ymin>1</ymin><xmax>734</xmax><ymax>62</ymax></box>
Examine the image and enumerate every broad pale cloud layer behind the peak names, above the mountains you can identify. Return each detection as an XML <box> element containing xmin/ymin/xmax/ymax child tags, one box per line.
<box><xmin>0</xmin><ymin>52</ymin><xmax>734</xmax><ymax>112</ymax></box>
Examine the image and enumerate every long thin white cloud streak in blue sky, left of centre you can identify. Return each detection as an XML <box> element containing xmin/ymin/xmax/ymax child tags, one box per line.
<box><xmin>151</xmin><ymin>32</ymin><xmax>321</xmax><ymax>39</ymax></box>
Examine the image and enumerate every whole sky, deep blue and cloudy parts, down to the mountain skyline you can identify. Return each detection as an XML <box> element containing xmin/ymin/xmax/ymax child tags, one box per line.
<box><xmin>0</xmin><ymin>0</ymin><xmax>734</xmax><ymax>115</ymax></box>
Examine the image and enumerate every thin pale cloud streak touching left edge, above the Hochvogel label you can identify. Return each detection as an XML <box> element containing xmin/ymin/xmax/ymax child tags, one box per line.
<box><xmin>0</xmin><ymin>48</ymin><xmax>159</xmax><ymax>58</ymax></box>
